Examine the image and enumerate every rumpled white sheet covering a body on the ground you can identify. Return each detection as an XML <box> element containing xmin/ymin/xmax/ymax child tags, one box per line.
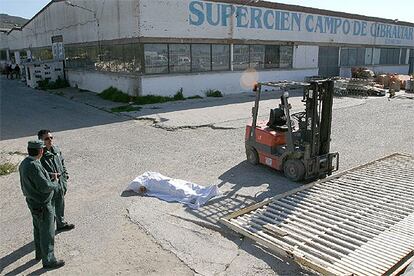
<box><xmin>126</xmin><ymin>172</ymin><xmax>220</xmax><ymax>209</ymax></box>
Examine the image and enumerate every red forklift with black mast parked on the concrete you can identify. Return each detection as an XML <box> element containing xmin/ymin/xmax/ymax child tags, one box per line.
<box><xmin>245</xmin><ymin>80</ymin><xmax>339</xmax><ymax>182</ymax></box>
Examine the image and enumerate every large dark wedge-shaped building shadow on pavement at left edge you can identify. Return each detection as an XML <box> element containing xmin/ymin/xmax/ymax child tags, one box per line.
<box><xmin>0</xmin><ymin>77</ymin><xmax>130</xmax><ymax>140</ymax></box>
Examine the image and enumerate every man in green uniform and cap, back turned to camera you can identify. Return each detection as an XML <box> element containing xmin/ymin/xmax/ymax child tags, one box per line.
<box><xmin>19</xmin><ymin>141</ymin><xmax>65</xmax><ymax>269</ymax></box>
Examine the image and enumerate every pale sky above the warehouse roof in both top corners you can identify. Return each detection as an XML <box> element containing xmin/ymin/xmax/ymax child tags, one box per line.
<box><xmin>0</xmin><ymin>0</ymin><xmax>414</xmax><ymax>23</ymax></box>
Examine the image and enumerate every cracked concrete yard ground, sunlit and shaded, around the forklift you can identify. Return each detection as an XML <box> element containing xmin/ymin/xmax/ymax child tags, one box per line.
<box><xmin>0</xmin><ymin>78</ymin><xmax>414</xmax><ymax>275</ymax></box>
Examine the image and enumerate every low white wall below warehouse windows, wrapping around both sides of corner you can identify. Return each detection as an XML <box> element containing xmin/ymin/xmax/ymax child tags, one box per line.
<box><xmin>66</xmin><ymin>68</ymin><xmax>318</xmax><ymax>97</ymax></box>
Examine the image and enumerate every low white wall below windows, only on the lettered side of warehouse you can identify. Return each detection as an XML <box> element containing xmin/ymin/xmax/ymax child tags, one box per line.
<box><xmin>142</xmin><ymin>68</ymin><xmax>318</xmax><ymax>97</ymax></box>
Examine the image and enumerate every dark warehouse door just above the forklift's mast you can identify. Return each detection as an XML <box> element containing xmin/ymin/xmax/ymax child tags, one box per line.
<box><xmin>318</xmin><ymin>46</ymin><xmax>339</xmax><ymax>77</ymax></box>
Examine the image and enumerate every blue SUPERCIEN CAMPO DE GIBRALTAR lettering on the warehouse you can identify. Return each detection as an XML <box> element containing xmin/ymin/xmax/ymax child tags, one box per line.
<box><xmin>188</xmin><ymin>0</ymin><xmax>414</xmax><ymax>44</ymax></box>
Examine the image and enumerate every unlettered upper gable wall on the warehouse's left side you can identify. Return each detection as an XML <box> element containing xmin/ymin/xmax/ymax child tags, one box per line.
<box><xmin>6</xmin><ymin>0</ymin><xmax>139</xmax><ymax>49</ymax></box>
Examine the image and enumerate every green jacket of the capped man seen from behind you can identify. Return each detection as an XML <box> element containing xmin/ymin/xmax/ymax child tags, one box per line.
<box><xmin>19</xmin><ymin>156</ymin><xmax>57</xmax><ymax>206</ymax></box>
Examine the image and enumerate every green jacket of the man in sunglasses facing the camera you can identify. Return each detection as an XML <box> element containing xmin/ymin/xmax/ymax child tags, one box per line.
<box><xmin>40</xmin><ymin>146</ymin><xmax>68</xmax><ymax>192</ymax></box>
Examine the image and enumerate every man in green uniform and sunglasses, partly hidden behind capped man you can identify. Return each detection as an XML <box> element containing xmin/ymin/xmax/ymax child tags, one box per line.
<box><xmin>37</xmin><ymin>129</ymin><xmax>75</xmax><ymax>231</ymax></box>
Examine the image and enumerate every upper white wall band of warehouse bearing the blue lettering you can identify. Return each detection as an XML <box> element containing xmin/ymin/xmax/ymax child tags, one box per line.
<box><xmin>140</xmin><ymin>0</ymin><xmax>414</xmax><ymax>46</ymax></box>
